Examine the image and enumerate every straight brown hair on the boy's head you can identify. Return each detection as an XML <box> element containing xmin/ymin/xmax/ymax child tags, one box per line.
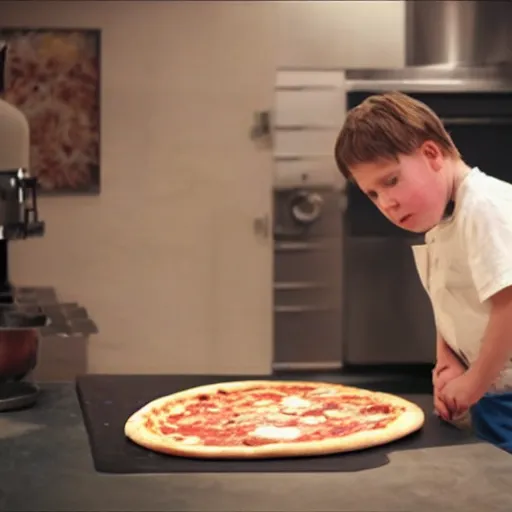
<box><xmin>334</xmin><ymin>92</ymin><xmax>460</xmax><ymax>179</ymax></box>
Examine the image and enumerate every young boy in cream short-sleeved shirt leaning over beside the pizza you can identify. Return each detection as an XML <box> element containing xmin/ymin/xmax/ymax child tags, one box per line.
<box><xmin>335</xmin><ymin>92</ymin><xmax>512</xmax><ymax>453</ymax></box>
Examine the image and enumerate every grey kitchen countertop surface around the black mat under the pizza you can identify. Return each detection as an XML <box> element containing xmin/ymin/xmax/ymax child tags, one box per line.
<box><xmin>0</xmin><ymin>382</ymin><xmax>512</xmax><ymax>512</ymax></box>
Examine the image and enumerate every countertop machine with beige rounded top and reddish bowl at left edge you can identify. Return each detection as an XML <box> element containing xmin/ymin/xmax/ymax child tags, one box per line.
<box><xmin>0</xmin><ymin>91</ymin><xmax>48</xmax><ymax>411</ymax></box>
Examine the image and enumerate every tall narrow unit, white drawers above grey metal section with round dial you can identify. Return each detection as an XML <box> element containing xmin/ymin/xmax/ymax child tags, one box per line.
<box><xmin>272</xmin><ymin>69</ymin><xmax>344</xmax><ymax>371</ymax></box>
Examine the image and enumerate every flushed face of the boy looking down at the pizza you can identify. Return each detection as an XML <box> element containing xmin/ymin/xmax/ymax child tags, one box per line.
<box><xmin>351</xmin><ymin>142</ymin><xmax>449</xmax><ymax>233</ymax></box>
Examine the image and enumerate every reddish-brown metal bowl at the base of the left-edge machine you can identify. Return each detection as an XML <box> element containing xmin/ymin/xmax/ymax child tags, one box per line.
<box><xmin>0</xmin><ymin>313</ymin><xmax>48</xmax><ymax>382</ymax></box>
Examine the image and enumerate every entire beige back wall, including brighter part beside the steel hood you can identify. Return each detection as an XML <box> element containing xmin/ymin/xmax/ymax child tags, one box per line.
<box><xmin>0</xmin><ymin>1</ymin><xmax>403</xmax><ymax>372</ymax></box>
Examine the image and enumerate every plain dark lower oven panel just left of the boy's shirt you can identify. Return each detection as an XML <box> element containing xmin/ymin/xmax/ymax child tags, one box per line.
<box><xmin>343</xmin><ymin>237</ymin><xmax>436</xmax><ymax>364</ymax></box>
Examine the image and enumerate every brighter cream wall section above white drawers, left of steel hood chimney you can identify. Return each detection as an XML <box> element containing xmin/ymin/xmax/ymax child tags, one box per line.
<box><xmin>276</xmin><ymin>0</ymin><xmax>405</xmax><ymax>68</ymax></box>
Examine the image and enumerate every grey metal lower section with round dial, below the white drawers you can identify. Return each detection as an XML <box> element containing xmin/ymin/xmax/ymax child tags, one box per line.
<box><xmin>273</xmin><ymin>187</ymin><xmax>342</xmax><ymax>370</ymax></box>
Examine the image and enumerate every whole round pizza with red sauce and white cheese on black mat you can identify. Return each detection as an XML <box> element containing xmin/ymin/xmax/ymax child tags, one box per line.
<box><xmin>124</xmin><ymin>380</ymin><xmax>425</xmax><ymax>459</ymax></box>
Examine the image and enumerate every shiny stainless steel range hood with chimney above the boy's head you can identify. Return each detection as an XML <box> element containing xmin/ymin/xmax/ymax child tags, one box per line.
<box><xmin>346</xmin><ymin>0</ymin><xmax>512</xmax><ymax>89</ymax></box>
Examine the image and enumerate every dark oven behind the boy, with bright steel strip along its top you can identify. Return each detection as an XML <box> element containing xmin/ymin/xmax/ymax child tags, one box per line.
<box><xmin>342</xmin><ymin>67</ymin><xmax>512</xmax><ymax>365</ymax></box>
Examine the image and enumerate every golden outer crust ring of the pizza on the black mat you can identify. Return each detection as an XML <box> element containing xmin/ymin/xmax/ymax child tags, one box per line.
<box><xmin>124</xmin><ymin>380</ymin><xmax>425</xmax><ymax>459</ymax></box>
